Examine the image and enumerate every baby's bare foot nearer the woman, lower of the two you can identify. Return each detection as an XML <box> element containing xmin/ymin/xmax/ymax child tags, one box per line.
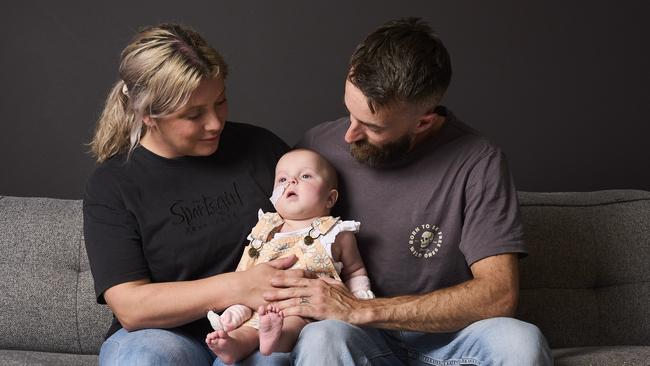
<box><xmin>205</xmin><ymin>326</ymin><xmax>259</xmax><ymax>364</ymax></box>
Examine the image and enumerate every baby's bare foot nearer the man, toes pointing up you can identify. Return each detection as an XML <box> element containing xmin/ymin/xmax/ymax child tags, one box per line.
<box><xmin>258</xmin><ymin>305</ymin><xmax>307</xmax><ymax>355</ymax></box>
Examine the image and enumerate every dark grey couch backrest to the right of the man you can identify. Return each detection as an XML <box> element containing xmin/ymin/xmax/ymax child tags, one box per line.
<box><xmin>518</xmin><ymin>190</ymin><xmax>650</xmax><ymax>348</ymax></box>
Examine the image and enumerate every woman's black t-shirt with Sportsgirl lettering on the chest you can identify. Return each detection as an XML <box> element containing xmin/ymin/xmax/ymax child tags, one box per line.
<box><xmin>83</xmin><ymin>122</ymin><xmax>288</xmax><ymax>339</ymax></box>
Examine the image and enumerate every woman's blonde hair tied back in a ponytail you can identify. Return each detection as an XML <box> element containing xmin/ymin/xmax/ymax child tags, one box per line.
<box><xmin>89</xmin><ymin>24</ymin><xmax>228</xmax><ymax>163</ymax></box>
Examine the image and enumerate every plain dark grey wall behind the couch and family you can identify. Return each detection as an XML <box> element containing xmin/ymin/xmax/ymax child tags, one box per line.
<box><xmin>0</xmin><ymin>0</ymin><xmax>650</xmax><ymax>198</ymax></box>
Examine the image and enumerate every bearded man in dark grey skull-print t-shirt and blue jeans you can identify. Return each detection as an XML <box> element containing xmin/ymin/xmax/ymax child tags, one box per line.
<box><xmin>266</xmin><ymin>18</ymin><xmax>552</xmax><ymax>365</ymax></box>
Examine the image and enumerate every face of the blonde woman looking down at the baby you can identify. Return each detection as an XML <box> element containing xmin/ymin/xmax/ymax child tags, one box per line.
<box><xmin>140</xmin><ymin>78</ymin><xmax>228</xmax><ymax>159</ymax></box>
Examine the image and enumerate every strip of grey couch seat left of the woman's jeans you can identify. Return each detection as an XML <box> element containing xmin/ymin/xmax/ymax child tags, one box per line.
<box><xmin>0</xmin><ymin>350</ymin><xmax>99</xmax><ymax>366</ymax></box>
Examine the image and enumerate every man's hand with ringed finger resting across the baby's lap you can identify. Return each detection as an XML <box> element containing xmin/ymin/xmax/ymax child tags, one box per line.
<box><xmin>264</xmin><ymin>276</ymin><xmax>362</xmax><ymax>324</ymax></box>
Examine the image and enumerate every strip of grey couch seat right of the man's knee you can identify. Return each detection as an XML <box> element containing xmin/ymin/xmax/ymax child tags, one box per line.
<box><xmin>553</xmin><ymin>346</ymin><xmax>650</xmax><ymax>366</ymax></box>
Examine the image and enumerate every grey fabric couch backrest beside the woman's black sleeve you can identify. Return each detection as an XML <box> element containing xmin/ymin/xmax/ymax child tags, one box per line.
<box><xmin>0</xmin><ymin>197</ymin><xmax>111</xmax><ymax>353</ymax></box>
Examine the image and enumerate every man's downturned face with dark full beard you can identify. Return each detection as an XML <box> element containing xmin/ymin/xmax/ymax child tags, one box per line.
<box><xmin>344</xmin><ymin>80</ymin><xmax>419</xmax><ymax>166</ymax></box>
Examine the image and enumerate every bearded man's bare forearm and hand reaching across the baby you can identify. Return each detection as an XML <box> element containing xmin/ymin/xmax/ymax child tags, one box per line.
<box><xmin>264</xmin><ymin>254</ymin><xmax>519</xmax><ymax>332</ymax></box>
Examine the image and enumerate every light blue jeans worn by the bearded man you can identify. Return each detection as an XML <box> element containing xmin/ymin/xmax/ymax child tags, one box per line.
<box><xmin>225</xmin><ymin>318</ymin><xmax>553</xmax><ymax>366</ymax></box>
